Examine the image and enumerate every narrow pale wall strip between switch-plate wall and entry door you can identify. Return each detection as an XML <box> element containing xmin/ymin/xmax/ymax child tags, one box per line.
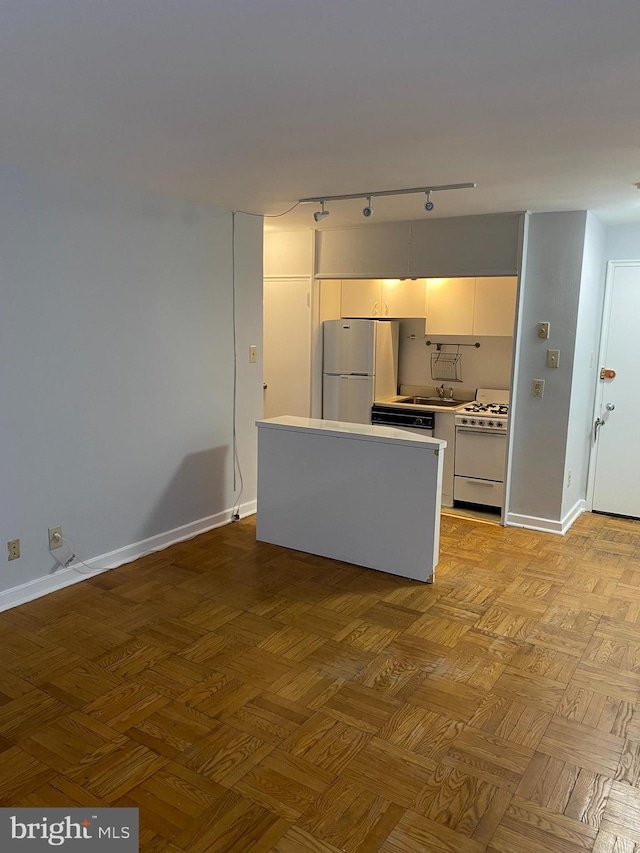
<box><xmin>560</xmin><ymin>213</ymin><xmax>605</xmax><ymax>518</ymax></box>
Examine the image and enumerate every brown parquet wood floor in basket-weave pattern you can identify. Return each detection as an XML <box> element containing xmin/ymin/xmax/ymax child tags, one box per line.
<box><xmin>0</xmin><ymin>514</ymin><xmax>640</xmax><ymax>853</ymax></box>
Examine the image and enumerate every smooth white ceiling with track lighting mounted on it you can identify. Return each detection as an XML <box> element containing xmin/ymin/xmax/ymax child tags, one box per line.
<box><xmin>0</xmin><ymin>0</ymin><xmax>640</xmax><ymax>228</ymax></box>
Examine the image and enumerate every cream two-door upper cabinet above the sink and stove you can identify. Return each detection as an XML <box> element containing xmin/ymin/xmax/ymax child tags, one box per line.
<box><xmin>425</xmin><ymin>276</ymin><xmax>518</xmax><ymax>337</ymax></box>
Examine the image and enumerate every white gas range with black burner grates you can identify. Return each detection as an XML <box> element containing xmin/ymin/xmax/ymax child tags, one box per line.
<box><xmin>453</xmin><ymin>388</ymin><xmax>509</xmax><ymax>508</ymax></box>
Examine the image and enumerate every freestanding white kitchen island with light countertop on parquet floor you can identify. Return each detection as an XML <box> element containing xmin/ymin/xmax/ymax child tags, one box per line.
<box><xmin>256</xmin><ymin>416</ymin><xmax>447</xmax><ymax>582</ymax></box>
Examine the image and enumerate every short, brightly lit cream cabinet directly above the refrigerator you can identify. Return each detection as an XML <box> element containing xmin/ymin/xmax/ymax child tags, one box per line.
<box><xmin>340</xmin><ymin>278</ymin><xmax>425</xmax><ymax>320</ymax></box>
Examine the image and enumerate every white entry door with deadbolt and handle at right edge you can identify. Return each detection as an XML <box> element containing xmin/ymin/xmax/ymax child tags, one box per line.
<box><xmin>593</xmin><ymin>262</ymin><xmax>640</xmax><ymax>518</ymax></box>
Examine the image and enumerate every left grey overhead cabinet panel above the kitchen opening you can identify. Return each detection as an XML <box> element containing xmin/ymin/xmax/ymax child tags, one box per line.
<box><xmin>316</xmin><ymin>222</ymin><xmax>411</xmax><ymax>278</ymax></box>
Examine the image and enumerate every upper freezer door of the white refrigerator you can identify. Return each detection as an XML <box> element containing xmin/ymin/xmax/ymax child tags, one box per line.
<box><xmin>322</xmin><ymin>320</ymin><xmax>376</xmax><ymax>375</ymax></box>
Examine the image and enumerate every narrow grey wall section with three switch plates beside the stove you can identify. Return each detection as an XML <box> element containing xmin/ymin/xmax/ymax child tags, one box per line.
<box><xmin>507</xmin><ymin>211</ymin><xmax>587</xmax><ymax>529</ymax></box>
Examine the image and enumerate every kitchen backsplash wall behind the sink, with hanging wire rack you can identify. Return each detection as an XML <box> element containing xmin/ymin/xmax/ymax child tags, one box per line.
<box><xmin>398</xmin><ymin>320</ymin><xmax>513</xmax><ymax>388</ymax></box>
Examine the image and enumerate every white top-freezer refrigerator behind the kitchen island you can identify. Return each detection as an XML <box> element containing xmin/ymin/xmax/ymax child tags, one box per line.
<box><xmin>322</xmin><ymin>320</ymin><xmax>399</xmax><ymax>424</ymax></box>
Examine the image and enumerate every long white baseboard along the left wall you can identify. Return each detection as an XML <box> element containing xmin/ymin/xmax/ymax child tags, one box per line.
<box><xmin>0</xmin><ymin>500</ymin><xmax>256</xmax><ymax>612</ymax></box>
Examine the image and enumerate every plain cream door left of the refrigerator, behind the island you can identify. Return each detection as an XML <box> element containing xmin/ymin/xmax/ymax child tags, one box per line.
<box><xmin>262</xmin><ymin>278</ymin><xmax>311</xmax><ymax>418</ymax></box>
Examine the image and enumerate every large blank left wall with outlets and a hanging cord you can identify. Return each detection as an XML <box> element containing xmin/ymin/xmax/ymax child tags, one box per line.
<box><xmin>0</xmin><ymin>169</ymin><xmax>262</xmax><ymax>606</ymax></box>
